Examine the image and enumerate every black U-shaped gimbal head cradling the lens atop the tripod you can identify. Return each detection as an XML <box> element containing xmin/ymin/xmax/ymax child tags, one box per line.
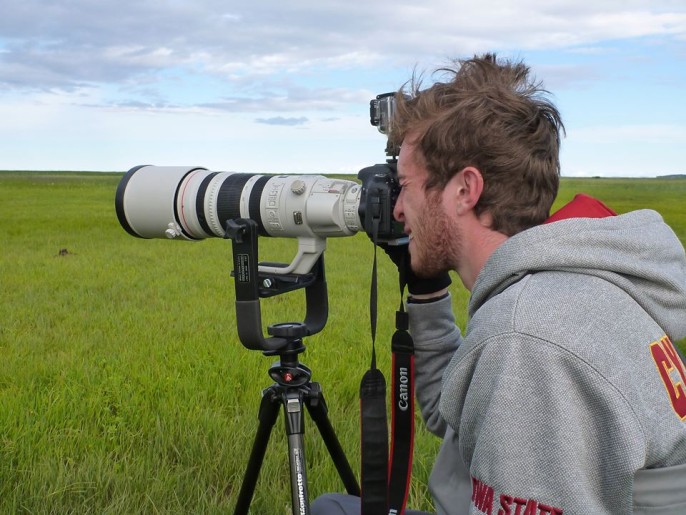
<box><xmin>224</xmin><ymin>218</ymin><xmax>329</xmax><ymax>354</ymax></box>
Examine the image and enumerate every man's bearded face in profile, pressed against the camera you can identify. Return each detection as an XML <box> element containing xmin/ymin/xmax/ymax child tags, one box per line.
<box><xmin>393</xmin><ymin>140</ymin><xmax>460</xmax><ymax>277</ymax></box>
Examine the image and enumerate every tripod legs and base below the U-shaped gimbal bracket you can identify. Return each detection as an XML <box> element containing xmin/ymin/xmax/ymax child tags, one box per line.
<box><xmin>234</xmin><ymin>324</ymin><xmax>360</xmax><ymax>515</ymax></box>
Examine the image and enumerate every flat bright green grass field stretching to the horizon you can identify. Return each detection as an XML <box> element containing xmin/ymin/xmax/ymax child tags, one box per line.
<box><xmin>0</xmin><ymin>172</ymin><xmax>686</xmax><ymax>514</ymax></box>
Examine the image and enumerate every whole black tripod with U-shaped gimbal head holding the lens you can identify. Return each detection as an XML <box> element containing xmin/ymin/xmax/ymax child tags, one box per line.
<box><xmin>226</xmin><ymin>219</ymin><xmax>360</xmax><ymax>515</ymax></box>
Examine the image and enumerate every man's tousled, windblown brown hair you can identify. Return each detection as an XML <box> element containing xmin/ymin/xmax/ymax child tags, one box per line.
<box><xmin>391</xmin><ymin>54</ymin><xmax>564</xmax><ymax>236</ymax></box>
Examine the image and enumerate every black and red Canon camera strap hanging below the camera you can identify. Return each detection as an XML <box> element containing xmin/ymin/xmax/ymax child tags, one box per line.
<box><xmin>360</xmin><ymin>223</ymin><xmax>414</xmax><ymax>515</ymax></box>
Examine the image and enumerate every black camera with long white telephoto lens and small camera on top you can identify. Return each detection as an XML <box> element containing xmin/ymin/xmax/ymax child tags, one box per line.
<box><xmin>115</xmin><ymin>94</ymin><xmax>406</xmax><ymax>273</ymax></box>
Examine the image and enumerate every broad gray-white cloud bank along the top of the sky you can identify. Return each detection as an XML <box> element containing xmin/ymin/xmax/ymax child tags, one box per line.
<box><xmin>0</xmin><ymin>0</ymin><xmax>686</xmax><ymax>93</ymax></box>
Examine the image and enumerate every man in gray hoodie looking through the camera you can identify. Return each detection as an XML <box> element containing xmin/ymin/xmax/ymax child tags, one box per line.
<box><xmin>322</xmin><ymin>55</ymin><xmax>686</xmax><ymax>515</ymax></box>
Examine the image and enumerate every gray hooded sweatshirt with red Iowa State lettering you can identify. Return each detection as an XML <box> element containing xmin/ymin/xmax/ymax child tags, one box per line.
<box><xmin>408</xmin><ymin>210</ymin><xmax>686</xmax><ymax>515</ymax></box>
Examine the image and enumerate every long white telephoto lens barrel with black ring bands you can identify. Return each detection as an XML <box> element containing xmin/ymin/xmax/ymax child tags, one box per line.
<box><xmin>115</xmin><ymin>166</ymin><xmax>362</xmax><ymax>240</ymax></box>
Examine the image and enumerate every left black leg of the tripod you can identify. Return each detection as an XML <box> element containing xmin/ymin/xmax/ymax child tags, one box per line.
<box><xmin>234</xmin><ymin>386</ymin><xmax>281</xmax><ymax>515</ymax></box>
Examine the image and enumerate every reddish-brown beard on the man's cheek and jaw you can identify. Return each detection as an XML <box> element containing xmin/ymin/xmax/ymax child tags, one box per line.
<box><xmin>410</xmin><ymin>191</ymin><xmax>462</xmax><ymax>278</ymax></box>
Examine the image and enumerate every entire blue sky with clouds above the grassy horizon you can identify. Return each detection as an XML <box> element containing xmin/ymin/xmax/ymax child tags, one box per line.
<box><xmin>0</xmin><ymin>0</ymin><xmax>686</xmax><ymax>177</ymax></box>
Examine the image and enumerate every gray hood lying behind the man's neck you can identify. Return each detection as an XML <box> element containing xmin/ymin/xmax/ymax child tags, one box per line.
<box><xmin>469</xmin><ymin>209</ymin><xmax>686</xmax><ymax>339</ymax></box>
